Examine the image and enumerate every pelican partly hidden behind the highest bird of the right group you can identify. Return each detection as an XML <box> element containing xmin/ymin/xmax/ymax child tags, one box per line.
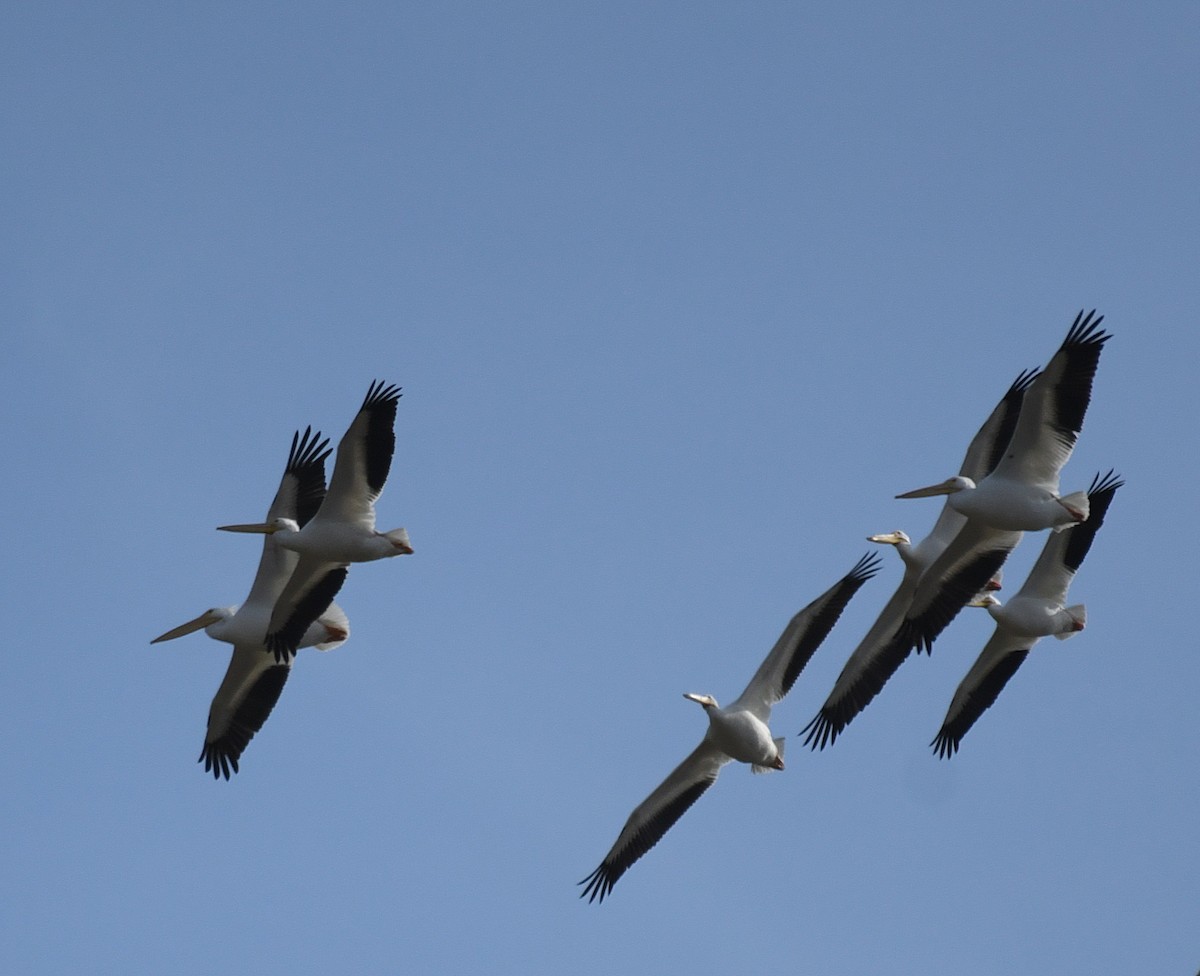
<box><xmin>800</xmin><ymin>370</ymin><xmax>1037</xmax><ymax>749</ymax></box>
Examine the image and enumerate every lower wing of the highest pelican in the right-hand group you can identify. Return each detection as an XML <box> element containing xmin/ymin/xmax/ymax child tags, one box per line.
<box><xmin>899</xmin><ymin>519</ymin><xmax>1024</xmax><ymax>652</ymax></box>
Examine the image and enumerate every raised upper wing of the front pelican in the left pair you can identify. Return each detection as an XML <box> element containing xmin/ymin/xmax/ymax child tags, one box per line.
<box><xmin>320</xmin><ymin>379</ymin><xmax>400</xmax><ymax>529</ymax></box>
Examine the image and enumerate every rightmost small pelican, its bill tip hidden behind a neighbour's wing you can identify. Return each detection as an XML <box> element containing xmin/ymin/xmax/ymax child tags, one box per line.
<box><xmin>930</xmin><ymin>471</ymin><xmax>1124</xmax><ymax>759</ymax></box>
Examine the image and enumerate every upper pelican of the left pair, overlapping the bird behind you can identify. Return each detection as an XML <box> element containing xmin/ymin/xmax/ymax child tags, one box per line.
<box><xmin>220</xmin><ymin>381</ymin><xmax>413</xmax><ymax>661</ymax></box>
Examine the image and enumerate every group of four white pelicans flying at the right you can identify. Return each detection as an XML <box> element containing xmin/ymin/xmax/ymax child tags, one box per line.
<box><xmin>580</xmin><ymin>312</ymin><xmax>1122</xmax><ymax>902</ymax></box>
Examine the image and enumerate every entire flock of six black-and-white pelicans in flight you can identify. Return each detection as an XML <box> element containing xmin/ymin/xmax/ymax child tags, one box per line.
<box><xmin>152</xmin><ymin>312</ymin><xmax>1122</xmax><ymax>902</ymax></box>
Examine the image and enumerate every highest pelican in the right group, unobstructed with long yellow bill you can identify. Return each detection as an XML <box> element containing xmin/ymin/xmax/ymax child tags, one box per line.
<box><xmin>896</xmin><ymin>311</ymin><xmax>1111</xmax><ymax>651</ymax></box>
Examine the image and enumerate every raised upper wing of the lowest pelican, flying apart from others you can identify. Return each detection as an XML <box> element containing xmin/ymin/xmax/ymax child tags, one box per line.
<box><xmin>730</xmin><ymin>552</ymin><xmax>881</xmax><ymax>721</ymax></box>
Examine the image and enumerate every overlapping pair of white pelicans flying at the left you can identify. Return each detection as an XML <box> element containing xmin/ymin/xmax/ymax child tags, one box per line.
<box><xmin>151</xmin><ymin>382</ymin><xmax>413</xmax><ymax>779</ymax></box>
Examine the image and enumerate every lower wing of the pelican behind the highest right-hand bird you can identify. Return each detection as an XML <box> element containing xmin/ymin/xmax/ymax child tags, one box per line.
<box><xmin>800</xmin><ymin>571</ymin><xmax>916</xmax><ymax>749</ymax></box>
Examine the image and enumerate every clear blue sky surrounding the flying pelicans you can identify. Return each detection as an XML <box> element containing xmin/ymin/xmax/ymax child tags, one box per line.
<box><xmin>0</xmin><ymin>2</ymin><xmax>1200</xmax><ymax>976</ymax></box>
